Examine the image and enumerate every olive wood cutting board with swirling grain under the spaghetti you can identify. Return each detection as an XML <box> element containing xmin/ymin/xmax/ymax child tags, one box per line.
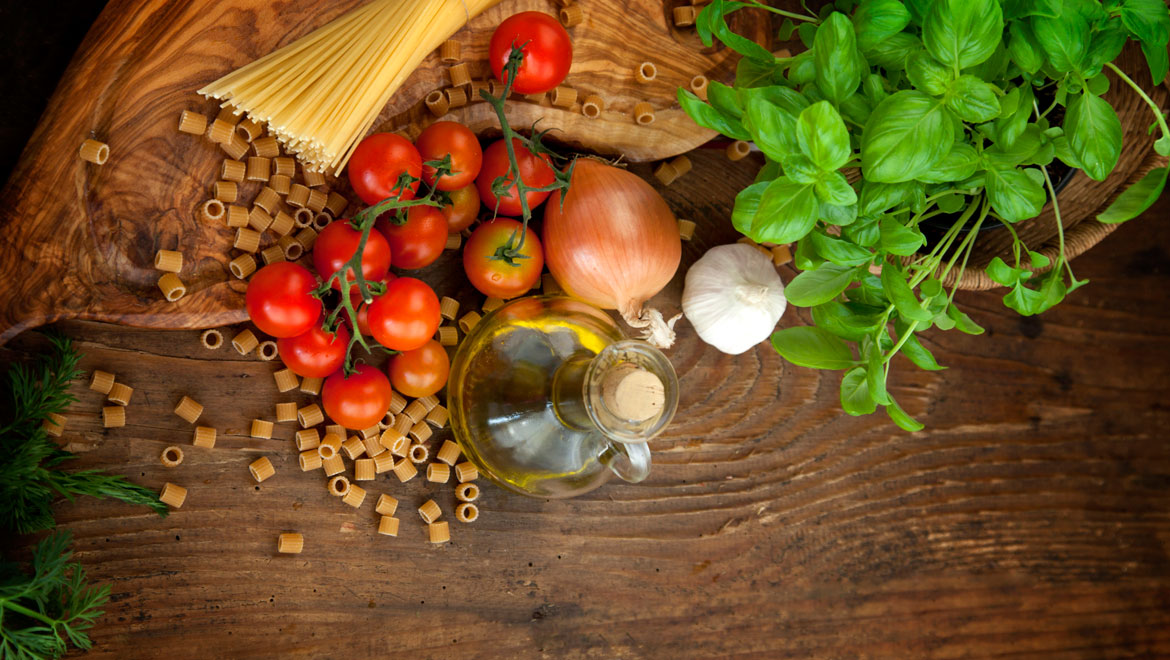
<box><xmin>0</xmin><ymin>0</ymin><xmax>769</xmax><ymax>344</ymax></box>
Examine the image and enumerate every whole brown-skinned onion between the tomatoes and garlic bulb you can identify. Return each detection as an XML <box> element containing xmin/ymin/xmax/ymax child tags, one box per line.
<box><xmin>543</xmin><ymin>158</ymin><xmax>682</xmax><ymax>348</ymax></box>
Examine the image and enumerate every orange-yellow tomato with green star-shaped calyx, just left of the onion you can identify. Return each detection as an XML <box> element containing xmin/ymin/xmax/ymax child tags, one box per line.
<box><xmin>463</xmin><ymin>218</ymin><xmax>544</xmax><ymax>298</ymax></box>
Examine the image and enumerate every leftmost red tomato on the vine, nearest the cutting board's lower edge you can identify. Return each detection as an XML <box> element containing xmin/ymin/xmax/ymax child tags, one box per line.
<box><xmin>245</xmin><ymin>261</ymin><xmax>321</xmax><ymax>337</ymax></box>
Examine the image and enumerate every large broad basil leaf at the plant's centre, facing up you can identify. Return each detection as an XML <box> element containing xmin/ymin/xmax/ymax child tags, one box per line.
<box><xmin>861</xmin><ymin>90</ymin><xmax>955</xmax><ymax>184</ymax></box>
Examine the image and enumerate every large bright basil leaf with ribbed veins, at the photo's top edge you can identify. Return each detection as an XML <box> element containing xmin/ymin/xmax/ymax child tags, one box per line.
<box><xmin>922</xmin><ymin>0</ymin><xmax>1004</xmax><ymax>70</ymax></box>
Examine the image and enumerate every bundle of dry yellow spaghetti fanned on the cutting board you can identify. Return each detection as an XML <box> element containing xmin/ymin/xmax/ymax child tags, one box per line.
<box><xmin>199</xmin><ymin>0</ymin><xmax>500</xmax><ymax>173</ymax></box>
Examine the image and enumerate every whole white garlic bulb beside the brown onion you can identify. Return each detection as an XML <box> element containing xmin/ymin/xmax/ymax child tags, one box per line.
<box><xmin>682</xmin><ymin>243</ymin><xmax>787</xmax><ymax>356</ymax></box>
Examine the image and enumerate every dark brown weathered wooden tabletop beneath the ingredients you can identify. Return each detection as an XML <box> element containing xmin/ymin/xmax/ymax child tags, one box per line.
<box><xmin>0</xmin><ymin>150</ymin><xmax>1170</xmax><ymax>659</ymax></box>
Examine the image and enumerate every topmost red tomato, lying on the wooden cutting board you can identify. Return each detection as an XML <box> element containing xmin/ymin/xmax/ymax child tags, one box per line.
<box><xmin>488</xmin><ymin>12</ymin><xmax>573</xmax><ymax>94</ymax></box>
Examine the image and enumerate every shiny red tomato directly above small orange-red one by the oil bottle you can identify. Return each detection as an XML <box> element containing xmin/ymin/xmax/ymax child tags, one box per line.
<box><xmin>370</xmin><ymin>277</ymin><xmax>442</xmax><ymax>353</ymax></box>
